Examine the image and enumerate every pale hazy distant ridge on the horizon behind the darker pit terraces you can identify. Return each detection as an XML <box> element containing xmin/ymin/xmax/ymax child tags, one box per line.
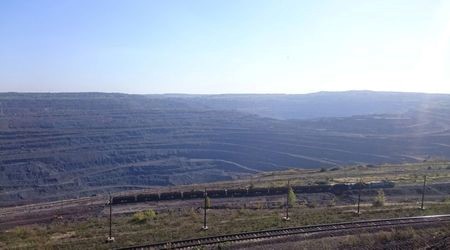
<box><xmin>159</xmin><ymin>91</ymin><xmax>450</xmax><ymax>119</ymax></box>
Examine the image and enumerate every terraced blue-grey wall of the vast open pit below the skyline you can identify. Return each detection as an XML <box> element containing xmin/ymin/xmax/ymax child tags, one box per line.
<box><xmin>0</xmin><ymin>92</ymin><xmax>450</xmax><ymax>205</ymax></box>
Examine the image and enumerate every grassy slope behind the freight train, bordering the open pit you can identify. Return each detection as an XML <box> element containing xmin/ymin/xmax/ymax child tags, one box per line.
<box><xmin>118</xmin><ymin>161</ymin><xmax>450</xmax><ymax>194</ymax></box>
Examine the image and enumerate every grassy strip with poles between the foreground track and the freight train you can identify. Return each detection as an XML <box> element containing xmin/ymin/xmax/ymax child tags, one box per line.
<box><xmin>0</xmin><ymin>203</ymin><xmax>450</xmax><ymax>249</ymax></box>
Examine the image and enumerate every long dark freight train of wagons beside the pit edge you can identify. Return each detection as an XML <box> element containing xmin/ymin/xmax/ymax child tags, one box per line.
<box><xmin>112</xmin><ymin>181</ymin><xmax>394</xmax><ymax>204</ymax></box>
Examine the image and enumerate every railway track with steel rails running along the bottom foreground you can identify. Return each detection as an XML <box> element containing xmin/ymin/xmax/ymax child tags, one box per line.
<box><xmin>120</xmin><ymin>214</ymin><xmax>450</xmax><ymax>250</ymax></box>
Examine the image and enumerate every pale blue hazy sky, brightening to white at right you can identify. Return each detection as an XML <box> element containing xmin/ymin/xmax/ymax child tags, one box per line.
<box><xmin>0</xmin><ymin>0</ymin><xmax>450</xmax><ymax>93</ymax></box>
